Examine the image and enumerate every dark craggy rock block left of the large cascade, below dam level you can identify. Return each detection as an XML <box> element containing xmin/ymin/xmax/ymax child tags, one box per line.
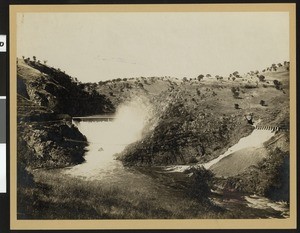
<box><xmin>18</xmin><ymin>123</ymin><xmax>87</xmax><ymax>168</ymax></box>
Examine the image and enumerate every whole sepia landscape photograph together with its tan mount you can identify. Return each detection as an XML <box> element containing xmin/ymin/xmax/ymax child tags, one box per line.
<box><xmin>10</xmin><ymin>4</ymin><xmax>296</xmax><ymax>229</ymax></box>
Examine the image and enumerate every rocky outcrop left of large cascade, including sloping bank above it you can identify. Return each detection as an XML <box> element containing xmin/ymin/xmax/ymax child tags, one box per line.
<box><xmin>17</xmin><ymin>93</ymin><xmax>87</xmax><ymax>168</ymax></box>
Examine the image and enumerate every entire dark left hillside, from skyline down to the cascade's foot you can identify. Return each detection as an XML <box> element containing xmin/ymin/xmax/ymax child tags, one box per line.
<box><xmin>17</xmin><ymin>61</ymin><xmax>114</xmax><ymax>169</ymax></box>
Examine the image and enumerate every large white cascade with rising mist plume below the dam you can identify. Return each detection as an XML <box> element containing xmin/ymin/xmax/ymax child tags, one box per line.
<box><xmin>67</xmin><ymin>98</ymin><xmax>153</xmax><ymax>179</ymax></box>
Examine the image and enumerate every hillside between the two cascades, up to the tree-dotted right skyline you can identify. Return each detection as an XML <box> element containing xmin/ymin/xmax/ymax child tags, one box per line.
<box><xmin>119</xmin><ymin>62</ymin><xmax>289</xmax><ymax>166</ymax></box>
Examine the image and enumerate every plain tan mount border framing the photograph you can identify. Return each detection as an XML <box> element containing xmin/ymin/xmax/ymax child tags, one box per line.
<box><xmin>9</xmin><ymin>3</ymin><xmax>297</xmax><ymax>230</ymax></box>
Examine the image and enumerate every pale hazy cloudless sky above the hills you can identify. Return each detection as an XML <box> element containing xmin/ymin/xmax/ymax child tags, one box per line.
<box><xmin>17</xmin><ymin>12</ymin><xmax>289</xmax><ymax>82</ymax></box>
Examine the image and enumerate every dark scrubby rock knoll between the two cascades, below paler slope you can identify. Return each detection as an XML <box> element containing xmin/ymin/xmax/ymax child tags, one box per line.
<box><xmin>119</xmin><ymin>93</ymin><xmax>253</xmax><ymax>166</ymax></box>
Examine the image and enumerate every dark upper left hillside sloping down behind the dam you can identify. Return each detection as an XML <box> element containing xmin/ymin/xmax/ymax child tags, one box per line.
<box><xmin>17</xmin><ymin>59</ymin><xmax>114</xmax><ymax>116</ymax></box>
